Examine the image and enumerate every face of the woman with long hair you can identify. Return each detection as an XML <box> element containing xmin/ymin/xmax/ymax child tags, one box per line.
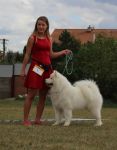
<box><xmin>37</xmin><ymin>20</ymin><xmax>47</xmax><ymax>34</ymax></box>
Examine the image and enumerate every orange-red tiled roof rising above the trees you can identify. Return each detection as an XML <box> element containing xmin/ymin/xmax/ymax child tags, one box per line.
<box><xmin>51</xmin><ymin>28</ymin><xmax>117</xmax><ymax>43</ymax></box>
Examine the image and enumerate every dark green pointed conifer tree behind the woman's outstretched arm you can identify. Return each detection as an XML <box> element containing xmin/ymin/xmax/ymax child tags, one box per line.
<box><xmin>52</xmin><ymin>30</ymin><xmax>81</xmax><ymax>81</ymax></box>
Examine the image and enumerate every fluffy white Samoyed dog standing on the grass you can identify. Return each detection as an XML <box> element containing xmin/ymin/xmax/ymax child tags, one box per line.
<box><xmin>45</xmin><ymin>70</ymin><xmax>103</xmax><ymax>126</ymax></box>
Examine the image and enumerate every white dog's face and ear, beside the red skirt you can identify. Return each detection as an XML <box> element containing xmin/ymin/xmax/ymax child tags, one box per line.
<box><xmin>45</xmin><ymin>70</ymin><xmax>57</xmax><ymax>87</ymax></box>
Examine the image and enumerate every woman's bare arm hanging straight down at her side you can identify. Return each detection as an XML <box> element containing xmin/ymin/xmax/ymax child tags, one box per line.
<box><xmin>20</xmin><ymin>36</ymin><xmax>34</xmax><ymax>76</ymax></box>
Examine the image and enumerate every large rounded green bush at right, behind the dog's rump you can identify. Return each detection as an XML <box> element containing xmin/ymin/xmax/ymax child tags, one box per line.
<box><xmin>78</xmin><ymin>36</ymin><xmax>117</xmax><ymax>102</ymax></box>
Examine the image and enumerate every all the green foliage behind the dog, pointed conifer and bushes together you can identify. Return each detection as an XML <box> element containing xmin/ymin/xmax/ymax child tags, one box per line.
<box><xmin>53</xmin><ymin>30</ymin><xmax>117</xmax><ymax>102</ymax></box>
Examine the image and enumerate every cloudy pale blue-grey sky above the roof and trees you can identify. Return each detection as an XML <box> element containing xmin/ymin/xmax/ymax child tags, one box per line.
<box><xmin>0</xmin><ymin>0</ymin><xmax>117</xmax><ymax>53</ymax></box>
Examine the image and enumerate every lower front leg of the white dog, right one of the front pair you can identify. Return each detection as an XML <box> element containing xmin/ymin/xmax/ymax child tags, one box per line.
<box><xmin>64</xmin><ymin>109</ymin><xmax>72</xmax><ymax>126</ymax></box>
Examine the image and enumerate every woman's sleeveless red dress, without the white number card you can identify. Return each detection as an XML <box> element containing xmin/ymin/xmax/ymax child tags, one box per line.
<box><xmin>24</xmin><ymin>37</ymin><xmax>53</xmax><ymax>89</ymax></box>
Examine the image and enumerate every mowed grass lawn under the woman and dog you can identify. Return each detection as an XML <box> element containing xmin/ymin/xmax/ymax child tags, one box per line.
<box><xmin>0</xmin><ymin>100</ymin><xmax>117</xmax><ymax>150</ymax></box>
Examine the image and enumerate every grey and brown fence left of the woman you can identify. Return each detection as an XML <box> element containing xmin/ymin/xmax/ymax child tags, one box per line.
<box><xmin>0</xmin><ymin>64</ymin><xmax>29</xmax><ymax>99</ymax></box>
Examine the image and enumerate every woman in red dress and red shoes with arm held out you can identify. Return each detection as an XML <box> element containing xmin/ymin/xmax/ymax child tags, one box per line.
<box><xmin>21</xmin><ymin>16</ymin><xmax>71</xmax><ymax>126</ymax></box>
